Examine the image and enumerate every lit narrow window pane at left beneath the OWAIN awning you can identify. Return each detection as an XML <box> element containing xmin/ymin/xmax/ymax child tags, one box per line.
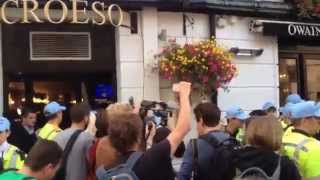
<box><xmin>279</xmin><ymin>58</ymin><xmax>298</xmax><ymax>105</ymax></box>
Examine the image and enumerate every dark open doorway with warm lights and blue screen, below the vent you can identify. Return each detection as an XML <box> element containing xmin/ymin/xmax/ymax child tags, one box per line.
<box><xmin>4</xmin><ymin>74</ymin><xmax>117</xmax><ymax>128</ymax></box>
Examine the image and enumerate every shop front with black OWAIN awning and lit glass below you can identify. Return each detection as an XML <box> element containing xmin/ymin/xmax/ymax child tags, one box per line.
<box><xmin>253</xmin><ymin>20</ymin><xmax>320</xmax><ymax>105</ymax></box>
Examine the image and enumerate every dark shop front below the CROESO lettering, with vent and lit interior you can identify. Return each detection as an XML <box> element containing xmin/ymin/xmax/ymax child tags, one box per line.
<box><xmin>2</xmin><ymin>23</ymin><xmax>117</xmax><ymax>127</ymax></box>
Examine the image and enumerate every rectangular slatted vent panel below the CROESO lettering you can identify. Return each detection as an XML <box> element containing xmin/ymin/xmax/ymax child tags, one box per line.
<box><xmin>30</xmin><ymin>32</ymin><xmax>91</xmax><ymax>60</ymax></box>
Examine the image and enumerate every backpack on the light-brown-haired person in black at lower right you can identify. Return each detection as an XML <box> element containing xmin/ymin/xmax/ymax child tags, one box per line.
<box><xmin>234</xmin><ymin>156</ymin><xmax>281</xmax><ymax>180</ymax></box>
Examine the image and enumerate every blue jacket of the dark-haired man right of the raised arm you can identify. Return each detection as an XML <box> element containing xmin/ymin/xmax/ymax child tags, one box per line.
<box><xmin>178</xmin><ymin>131</ymin><xmax>230</xmax><ymax>180</ymax></box>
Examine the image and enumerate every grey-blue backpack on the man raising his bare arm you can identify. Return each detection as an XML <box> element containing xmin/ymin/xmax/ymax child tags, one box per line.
<box><xmin>96</xmin><ymin>152</ymin><xmax>143</xmax><ymax>180</ymax></box>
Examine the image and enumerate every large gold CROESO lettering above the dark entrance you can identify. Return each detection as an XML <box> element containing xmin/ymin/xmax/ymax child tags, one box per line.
<box><xmin>0</xmin><ymin>0</ymin><xmax>123</xmax><ymax>26</ymax></box>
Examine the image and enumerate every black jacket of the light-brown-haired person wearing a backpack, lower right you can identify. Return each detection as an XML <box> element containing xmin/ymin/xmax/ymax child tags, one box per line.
<box><xmin>233</xmin><ymin>147</ymin><xmax>301</xmax><ymax>180</ymax></box>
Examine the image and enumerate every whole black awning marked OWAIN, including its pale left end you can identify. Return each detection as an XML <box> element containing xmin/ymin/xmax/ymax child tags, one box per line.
<box><xmin>250</xmin><ymin>20</ymin><xmax>320</xmax><ymax>41</ymax></box>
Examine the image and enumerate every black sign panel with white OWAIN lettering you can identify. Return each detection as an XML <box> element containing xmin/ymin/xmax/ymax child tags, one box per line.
<box><xmin>263</xmin><ymin>22</ymin><xmax>320</xmax><ymax>40</ymax></box>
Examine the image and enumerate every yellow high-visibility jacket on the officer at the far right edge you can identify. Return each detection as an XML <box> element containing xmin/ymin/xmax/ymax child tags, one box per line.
<box><xmin>282</xmin><ymin>129</ymin><xmax>320</xmax><ymax>180</ymax></box>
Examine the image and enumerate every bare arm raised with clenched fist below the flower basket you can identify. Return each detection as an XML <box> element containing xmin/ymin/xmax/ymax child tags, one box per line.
<box><xmin>167</xmin><ymin>82</ymin><xmax>191</xmax><ymax>155</ymax></box>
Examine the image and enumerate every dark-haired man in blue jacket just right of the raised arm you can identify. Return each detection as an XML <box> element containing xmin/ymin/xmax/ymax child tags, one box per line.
<box><xmin>178</xmin><ymin>103</ymin><xmax>230</xmax><ymax>180</ymax></box>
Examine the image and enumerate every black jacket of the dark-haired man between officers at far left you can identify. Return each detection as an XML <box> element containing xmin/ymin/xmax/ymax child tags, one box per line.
<box><xmin>8</xmin><ymin>122</ymin><xmax>37</xmax><ymax>153</ymax></box>
